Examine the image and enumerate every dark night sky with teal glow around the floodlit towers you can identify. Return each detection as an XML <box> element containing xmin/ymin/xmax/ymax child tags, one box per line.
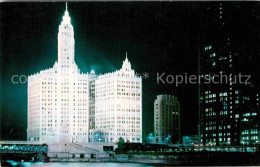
<box><xmin>0</xmin><ymin>2</ymin><xmax>259</xmax><ymax>140</ymax></box>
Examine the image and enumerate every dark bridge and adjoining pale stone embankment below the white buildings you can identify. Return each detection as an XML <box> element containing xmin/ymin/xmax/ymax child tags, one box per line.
<box><xmin>0</xmin><ymin>141</ymin><xmax>115</xmax><ymax>161</ymax></box>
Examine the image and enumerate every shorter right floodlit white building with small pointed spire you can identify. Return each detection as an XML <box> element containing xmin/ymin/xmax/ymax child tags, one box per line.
<box><xmin>89</xmin><ymin>57</ymin><xmax>142</xmax><ymax>142</ymax></box>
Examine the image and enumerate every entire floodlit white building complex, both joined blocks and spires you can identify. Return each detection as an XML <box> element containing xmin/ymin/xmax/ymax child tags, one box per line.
<box><xmin>27</xmin><ymin>4</ymin><xmax>142</xmax><ymax>143</ymax></box>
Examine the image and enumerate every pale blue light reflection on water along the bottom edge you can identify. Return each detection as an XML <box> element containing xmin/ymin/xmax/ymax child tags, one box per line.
<box><xmin>3</xmin><ymin>161</ymin><xmax>158</xmax><ymax>167</ymax></box>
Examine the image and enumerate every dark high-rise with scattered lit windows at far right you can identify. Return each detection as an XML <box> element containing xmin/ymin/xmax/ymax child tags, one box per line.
<box><xmin>199</xmin><ymin>2</ymin><xmax>260</xmax><ymax>146</ymax></box>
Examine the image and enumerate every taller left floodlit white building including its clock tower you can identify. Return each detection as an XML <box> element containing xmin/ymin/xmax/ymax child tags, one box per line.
<box><xmin>28</xmin><ymin>5</ymin><xmax>89</xmax><ymax>143</ymax></box>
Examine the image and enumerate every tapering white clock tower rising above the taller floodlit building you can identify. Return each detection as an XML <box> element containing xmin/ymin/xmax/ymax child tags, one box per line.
<box><xmin>58</xmin><ymin>3</ymin><xmax>75</xmax><ymax>68</ymax></box>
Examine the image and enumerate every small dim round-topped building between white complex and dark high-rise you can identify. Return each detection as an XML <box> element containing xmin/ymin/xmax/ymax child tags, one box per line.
<box><xmin>154</xmin><ymin>95</ymin><xmax>180</xmax><ymax>144</ymax></box>
